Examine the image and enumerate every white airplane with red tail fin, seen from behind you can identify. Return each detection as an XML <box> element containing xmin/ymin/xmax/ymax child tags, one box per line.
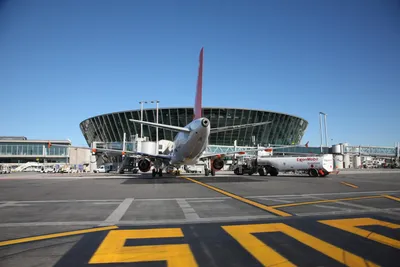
<box><xmin>123</xmin><ymin>48</ymin><xmax>282</xmax><ymax>177</ymax></box>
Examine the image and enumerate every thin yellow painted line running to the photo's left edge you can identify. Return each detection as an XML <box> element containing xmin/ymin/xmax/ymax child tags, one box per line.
<box><xmin>0</xmin><ymin>226</ymin><xmax>118</xmax><ymax>247</ymax></box>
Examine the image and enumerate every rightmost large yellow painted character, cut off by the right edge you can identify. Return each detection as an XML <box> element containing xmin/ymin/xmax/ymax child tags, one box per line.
<box><xmin>319</xmin><ymin>218</ymin><xmax>400</xmax><ymax>249</ymax></box>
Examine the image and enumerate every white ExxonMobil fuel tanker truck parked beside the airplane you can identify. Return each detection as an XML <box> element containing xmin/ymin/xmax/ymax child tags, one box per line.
<box><xmin>233</xmin><ymin>154</ymin><xmax>333</xmax><ymax>177</ymax></box>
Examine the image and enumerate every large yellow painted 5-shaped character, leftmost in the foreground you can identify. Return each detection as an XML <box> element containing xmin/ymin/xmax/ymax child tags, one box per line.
<box><xmin>89</xmin><ymin>228</ymin><xmax>198</xmax><ymax>267</ymax></box>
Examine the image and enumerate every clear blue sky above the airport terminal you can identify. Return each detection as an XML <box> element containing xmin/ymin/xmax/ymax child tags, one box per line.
<box><xmin>0</xmin><ymin>0</ymin><xmax>400</xmax><ymax>146</ymax></box>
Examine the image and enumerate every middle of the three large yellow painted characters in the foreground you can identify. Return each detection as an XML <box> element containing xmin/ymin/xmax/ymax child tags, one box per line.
<box><xmin>222</xmin><ymin>223</ymin><xmax>378</xmax><ymax>267</ymax></box>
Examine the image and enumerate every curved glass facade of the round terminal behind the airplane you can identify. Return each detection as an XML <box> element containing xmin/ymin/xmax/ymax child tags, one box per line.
<box><xmin>80</xmin><ymin>108</ymin><xmax>308</xmax><ymax>146</ymax></box>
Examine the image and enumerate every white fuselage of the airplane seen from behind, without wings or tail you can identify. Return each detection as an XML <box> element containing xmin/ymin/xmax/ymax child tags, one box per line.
<box><xmin>170</xmin><ymin>118</ymin><xmax>210</xmax><ymax>165</ymax></box>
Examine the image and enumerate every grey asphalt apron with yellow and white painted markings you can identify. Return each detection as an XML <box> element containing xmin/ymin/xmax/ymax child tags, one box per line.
<box><xmin>0</xmin><ymin>172</ymin><xmax>400</xmax><ymax>267</ymax></box>
